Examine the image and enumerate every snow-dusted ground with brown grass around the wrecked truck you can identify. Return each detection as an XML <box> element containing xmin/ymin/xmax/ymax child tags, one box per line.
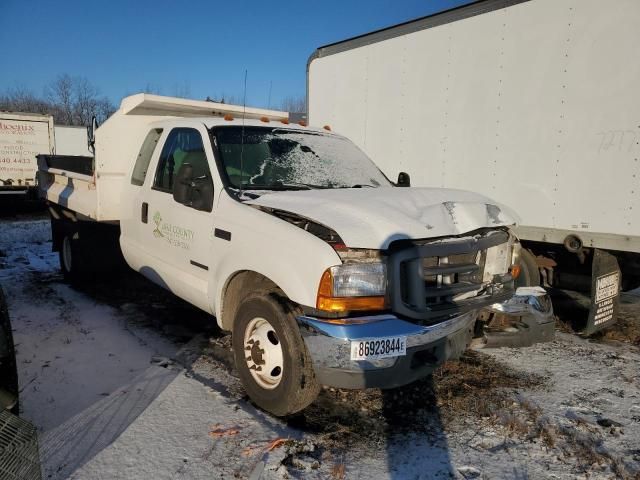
<box><xmin>0</xmin><ymin>219</ymin><xmax>640</xmax><ymax>479</ymax></box>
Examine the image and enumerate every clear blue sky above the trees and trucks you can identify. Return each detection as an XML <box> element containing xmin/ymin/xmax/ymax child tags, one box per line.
<box><xmin>0</xmin><ymin>0</ymin><xmax>469</xmax><ymax>106</ymax></box>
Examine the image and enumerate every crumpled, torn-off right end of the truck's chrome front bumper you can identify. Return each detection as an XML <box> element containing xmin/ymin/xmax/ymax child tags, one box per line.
<box><xmin>479</xmin><ymin>287</ymin><xmax>556</xmax><ymax>348</ymax></box>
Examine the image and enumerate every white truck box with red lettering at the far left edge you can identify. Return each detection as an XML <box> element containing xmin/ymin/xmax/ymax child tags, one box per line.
<box><xmin>0</xmin><ymin>112</ymin><xmax>55</xmax><ymax>195</ymax></box>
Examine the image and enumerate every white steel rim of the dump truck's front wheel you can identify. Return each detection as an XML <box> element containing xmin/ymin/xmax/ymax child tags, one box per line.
<box><xmin>243</xmin><ymin>317</ymin><xmax>284</xmax><ymax>390</ymax></box>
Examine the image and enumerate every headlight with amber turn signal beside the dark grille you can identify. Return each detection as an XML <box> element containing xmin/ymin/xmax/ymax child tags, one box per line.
<box><xmin>316</xmin><ymin>262</ymin><xmax>387</xmax><ymax>312</ymax></box>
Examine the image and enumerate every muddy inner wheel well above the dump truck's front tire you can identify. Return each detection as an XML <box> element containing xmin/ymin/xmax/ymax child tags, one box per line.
<box><xmin>220</xmin><ymin>270</ymin><xmax>284</xmax><ymax>331</ymax></box>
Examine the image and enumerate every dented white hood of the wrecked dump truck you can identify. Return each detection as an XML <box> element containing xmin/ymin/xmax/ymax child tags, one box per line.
<box><xmin>246</xmin><ymin>187</ymin><xmax>518</xmax><ymax>249</ymax></box>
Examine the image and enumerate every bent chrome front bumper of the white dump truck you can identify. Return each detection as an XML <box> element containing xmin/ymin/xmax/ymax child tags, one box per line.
<box><xmin>297</xmin><ymin>289</ymin><xmax>555</xmax><ymax>388</ymax></box>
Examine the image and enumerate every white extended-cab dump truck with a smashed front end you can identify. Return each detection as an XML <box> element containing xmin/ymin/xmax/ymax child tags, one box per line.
<box><xmin>39</xmin><ymin>94</ymin><xmax>554</xmax><ymax>415</ymax></box>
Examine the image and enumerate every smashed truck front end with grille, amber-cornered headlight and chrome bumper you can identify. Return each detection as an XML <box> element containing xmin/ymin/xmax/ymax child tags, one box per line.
<box><xmin>297</xmin><ymin>228</ymin><xmax>555</xmax><ymax>388</ymax></box>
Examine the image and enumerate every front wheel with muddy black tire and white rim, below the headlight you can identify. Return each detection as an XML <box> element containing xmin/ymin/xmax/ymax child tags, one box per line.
<box><xmin>232</xmin><ymin>292</ymin><xmax>320</xmax><ymax>417</ymax></box>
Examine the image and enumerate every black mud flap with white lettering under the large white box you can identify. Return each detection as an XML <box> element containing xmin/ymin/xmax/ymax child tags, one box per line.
<box><xmin>580</xmin><ymin>248</ymin><xmax>621</xmax><ymax>335</ymax></box>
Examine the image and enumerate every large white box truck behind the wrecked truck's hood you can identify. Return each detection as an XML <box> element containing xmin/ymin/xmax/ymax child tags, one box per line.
<box><xmin>307</xmin><ymin>0</ymin><xmax>640</xmax><ymax>289</ymax></box>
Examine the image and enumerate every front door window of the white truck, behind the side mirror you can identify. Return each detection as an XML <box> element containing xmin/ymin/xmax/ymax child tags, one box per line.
<box><xmin>153</xmin><ymin>128</ymin><xmax>211</xmax><ymax>193</ymax></box>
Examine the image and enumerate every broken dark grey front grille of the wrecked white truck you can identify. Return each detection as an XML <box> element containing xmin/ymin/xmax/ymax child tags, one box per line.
<box><xmin>388</xmin><ymin>230</ymin><xmax>513</xmax><ymax>321</ymax></box>
